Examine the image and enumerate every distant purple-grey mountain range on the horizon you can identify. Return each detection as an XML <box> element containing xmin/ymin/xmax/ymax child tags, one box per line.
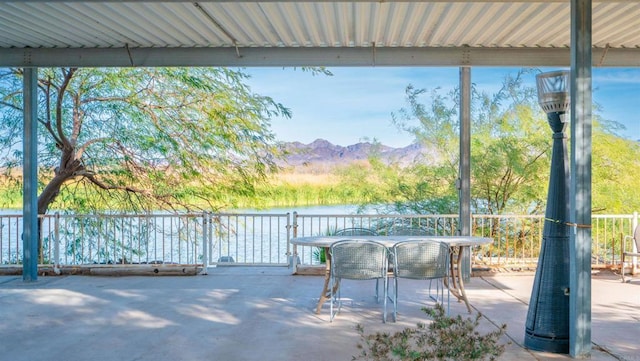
<box><xmin>279</xmin><ymin>139</ymin><xmax>433</xmax><ymax>168</ymax></box>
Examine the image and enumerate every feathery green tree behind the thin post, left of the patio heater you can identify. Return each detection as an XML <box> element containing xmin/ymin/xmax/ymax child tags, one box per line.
<box><xmin>393</xmin><ymin>71</ymin><xmax>550</xmax><ymax>214</ymax></box>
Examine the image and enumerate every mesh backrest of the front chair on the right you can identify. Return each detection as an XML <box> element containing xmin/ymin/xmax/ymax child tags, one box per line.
<box><xmin>393</xmin><ymin>240</ymin><xmax>449</xmax><ymax>279</ymax></box>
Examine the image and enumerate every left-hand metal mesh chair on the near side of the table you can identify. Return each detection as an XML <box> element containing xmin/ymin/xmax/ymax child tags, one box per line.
<box><xmin>329</xmin><ymin>239</ymin><xmax>388</xmax><ymax>322</ymax></box>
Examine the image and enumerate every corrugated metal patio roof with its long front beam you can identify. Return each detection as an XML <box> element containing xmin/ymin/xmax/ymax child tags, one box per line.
<box><xmin>0</xmin><ymin>0</ymin><xmax>640</xmax><ymax>66</ymax></box>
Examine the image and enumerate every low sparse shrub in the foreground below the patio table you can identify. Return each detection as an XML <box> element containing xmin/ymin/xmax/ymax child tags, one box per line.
<box><xmin>353</xmin><ymin>304</ymin><xmax>507</xmax><ymax>361</ymax></box>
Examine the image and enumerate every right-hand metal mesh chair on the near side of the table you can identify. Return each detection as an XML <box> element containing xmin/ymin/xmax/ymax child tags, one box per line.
<box><xmin>392</xmin><ymin>240</ymin><xmax>450</xmax><ymax>321</ymax></box>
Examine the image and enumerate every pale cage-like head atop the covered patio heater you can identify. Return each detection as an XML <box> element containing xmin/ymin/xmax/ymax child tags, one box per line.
<box><xmin>536</xmin><ymin>70</ymin><xmax>571</xmax><ymax>114</ymax></box>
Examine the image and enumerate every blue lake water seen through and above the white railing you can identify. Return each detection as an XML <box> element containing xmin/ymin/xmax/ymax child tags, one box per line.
<box><xmin>0</xmin><ymin>205</ymin><xmax>370</xmax><ymax>264</ymax></box>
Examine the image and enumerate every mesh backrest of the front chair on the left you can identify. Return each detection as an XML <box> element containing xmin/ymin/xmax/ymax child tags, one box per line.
<box><xmin>330</xmin><ymin>240</ymin><xmax>388</xmax><ymax>280</ymax></box>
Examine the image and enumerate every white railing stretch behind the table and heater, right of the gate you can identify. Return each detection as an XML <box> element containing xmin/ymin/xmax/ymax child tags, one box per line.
<box><xmin>293</xmin><ymin>212</ymin><xmax>638</xmax><ymax>267</ymax></box>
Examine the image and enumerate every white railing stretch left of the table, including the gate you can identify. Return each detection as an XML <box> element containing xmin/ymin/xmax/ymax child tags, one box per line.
<box><xmin>0</xmin><ymin>213</ymin><xmax>290</xmax><ymax>266</ymax></box>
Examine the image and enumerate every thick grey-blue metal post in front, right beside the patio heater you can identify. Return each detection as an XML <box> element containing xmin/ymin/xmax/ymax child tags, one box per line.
<box><xmin>569</xmin><ymin>0</ymin><xmax>592</xmax><ymax>358</ymax></box>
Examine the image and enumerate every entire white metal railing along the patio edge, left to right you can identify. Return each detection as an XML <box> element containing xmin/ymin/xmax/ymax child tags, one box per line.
<box><xmin>0</xmin><ymin>208</ymin><xmax>638</xmax><ymax>267</ymax></box>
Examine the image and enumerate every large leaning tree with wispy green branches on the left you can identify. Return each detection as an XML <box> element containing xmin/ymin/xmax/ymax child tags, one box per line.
<box><xmin>0</xmin><ymin>68</ymin><xmax>290</xmax><ymax>214</ymax></box>
